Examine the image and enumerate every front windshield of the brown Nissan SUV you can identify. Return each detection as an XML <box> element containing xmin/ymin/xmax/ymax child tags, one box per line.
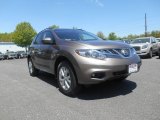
<box><xmin>55</xmin><ymin>30</ymin><xmax>99</xmax><ymax>41</ymax></box>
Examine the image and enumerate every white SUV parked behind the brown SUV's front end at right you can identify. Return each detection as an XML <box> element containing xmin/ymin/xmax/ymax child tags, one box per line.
<box><xmin>130</xmin><ymin>37</ymin><xmax>158</xmax><ymax>58</ymax></box>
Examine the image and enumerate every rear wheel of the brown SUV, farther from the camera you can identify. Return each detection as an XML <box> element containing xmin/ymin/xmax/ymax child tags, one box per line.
<box><xmin>28</xmin><ymin>59</ymin><xmax>39</xmax><ymax>76</ymax></box>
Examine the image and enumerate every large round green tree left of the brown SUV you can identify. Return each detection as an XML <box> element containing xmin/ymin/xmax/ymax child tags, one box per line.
<box><xmin>12</xmin><ymin>22</ymin><xmax>36</xmax><ymax>50</ymax></box>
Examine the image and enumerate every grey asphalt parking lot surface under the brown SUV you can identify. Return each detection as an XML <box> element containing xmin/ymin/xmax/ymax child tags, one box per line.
<box><xmin>0</xmin><ymin>56</ymin><xmax>160</xmax><ymax>120</ymax></box>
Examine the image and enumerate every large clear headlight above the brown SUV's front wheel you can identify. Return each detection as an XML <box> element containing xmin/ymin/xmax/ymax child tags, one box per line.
<box><xmin>76</xmin><ymin>49</ymin><xmax>107</xmax><ymax>60</ymax></box>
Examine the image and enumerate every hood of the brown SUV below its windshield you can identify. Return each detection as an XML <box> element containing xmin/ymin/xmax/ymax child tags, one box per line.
<box><xmin>63</xmin><ymin>40</ymin><xmax>131</xmax><ymax>49</ymax></box>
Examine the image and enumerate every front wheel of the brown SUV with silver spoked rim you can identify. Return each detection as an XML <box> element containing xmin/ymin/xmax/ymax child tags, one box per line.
<box><xmin>57</xmin><ymin>61</ymin><xmax>80</xmax><ymax>96</ymax></box>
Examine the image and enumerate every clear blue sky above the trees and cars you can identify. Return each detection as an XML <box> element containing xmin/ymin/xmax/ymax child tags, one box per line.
<box><xmin>0</xmin><ymin>0</ymin><xmax>160</xmax><ymax>37</ymax></box>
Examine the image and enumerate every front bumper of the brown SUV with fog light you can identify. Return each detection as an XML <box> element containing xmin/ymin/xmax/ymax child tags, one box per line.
<box><xmin>76</xmin><ymin>55</ymin><xmax>141</xmax><ymax>84</ymax></box>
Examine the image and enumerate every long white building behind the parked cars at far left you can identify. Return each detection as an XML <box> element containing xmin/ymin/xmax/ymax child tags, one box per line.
<box><xmin>0</xmin><ymin>42</ymin><xmax>25</xmax><ymax>53</ymax></box>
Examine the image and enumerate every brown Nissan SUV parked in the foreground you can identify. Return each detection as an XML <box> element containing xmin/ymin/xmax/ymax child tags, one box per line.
<box><xmin>28</xmin><ymin>29</ymin><xmax>141</xmax><ymax>95</ymax></box>
